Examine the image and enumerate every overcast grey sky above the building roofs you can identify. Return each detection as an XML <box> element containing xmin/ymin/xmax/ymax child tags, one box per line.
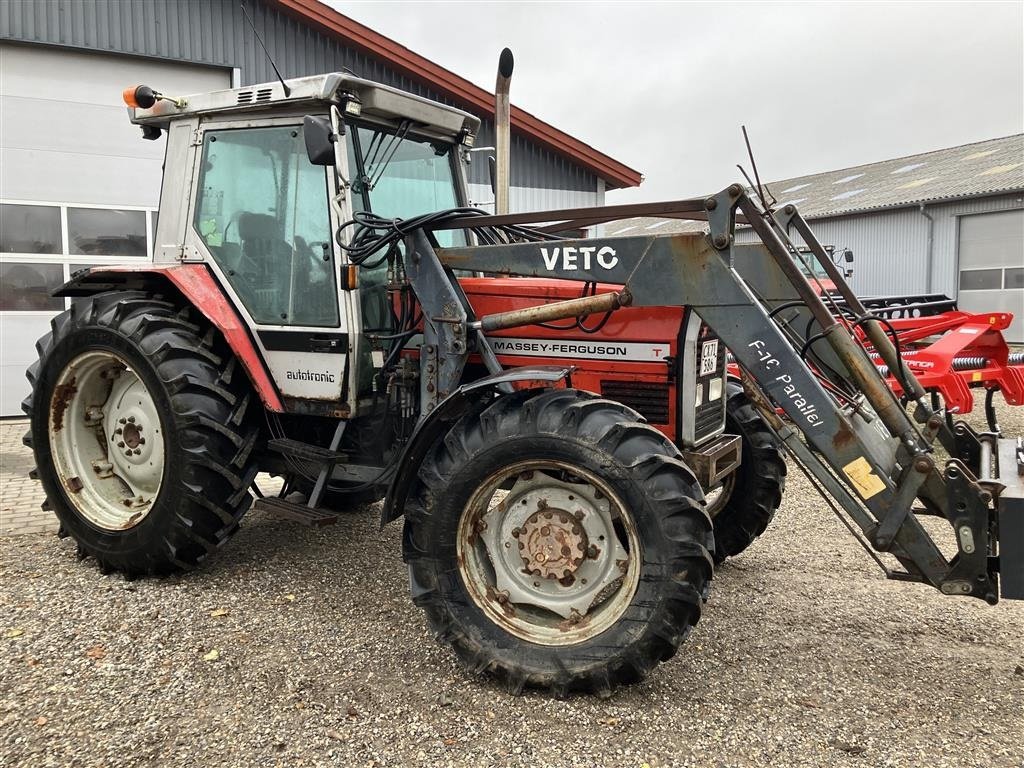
<box><xmin>329</xmin><ymin>0</ymin><xmax>1024</xmax><ymax>203</ymax></box>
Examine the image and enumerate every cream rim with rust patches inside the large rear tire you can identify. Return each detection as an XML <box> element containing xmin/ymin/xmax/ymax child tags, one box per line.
<box><xmin>49</xmin><ymin>350</ymin><xmax>164</xmax><ymax>530</ymax></box>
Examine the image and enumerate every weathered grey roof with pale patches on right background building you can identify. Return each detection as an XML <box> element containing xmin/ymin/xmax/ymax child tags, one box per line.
<box><xmin>767</xmin><ymin>134</ymin><xmax>1024</xmax><ymax>218</ymax></box>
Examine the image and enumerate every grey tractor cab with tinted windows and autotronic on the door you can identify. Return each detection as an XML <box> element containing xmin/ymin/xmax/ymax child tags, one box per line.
<box><xmin>125</xmin><ymin>74</ymin><xmax>479</xmax><ymax>417</ymax></box>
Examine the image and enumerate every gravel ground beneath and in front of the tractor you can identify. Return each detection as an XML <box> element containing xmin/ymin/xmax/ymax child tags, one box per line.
<box><xmin>0</xmin><ymin>393</ymin><xmax>1024</xmax><ymax>768</ymax></box>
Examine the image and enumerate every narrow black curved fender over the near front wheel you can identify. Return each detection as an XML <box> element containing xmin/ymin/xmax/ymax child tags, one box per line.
<box><xmin>381</xmin><ymin>366</ymin><xmax>574</xmax><ymax>527</ymax></box>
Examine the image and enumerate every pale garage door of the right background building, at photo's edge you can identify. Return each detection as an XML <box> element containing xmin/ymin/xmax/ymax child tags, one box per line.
<box><xmin>957</xmin><ymin>210</ymin><xmax>1024</xmax><ymax>344</ymax></box>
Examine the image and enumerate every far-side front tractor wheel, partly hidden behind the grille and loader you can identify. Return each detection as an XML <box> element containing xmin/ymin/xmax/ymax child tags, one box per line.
<box><xmin>708</xmin><ymin>382</ymin><xmax>785</xmax><ymax>564</ymax></box>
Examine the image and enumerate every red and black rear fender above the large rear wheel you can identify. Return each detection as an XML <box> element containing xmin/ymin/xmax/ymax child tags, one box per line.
<box><xmin>53</xmin><ymin>264</ymin><xmax>285</xmax><ymax>414</ymax></box>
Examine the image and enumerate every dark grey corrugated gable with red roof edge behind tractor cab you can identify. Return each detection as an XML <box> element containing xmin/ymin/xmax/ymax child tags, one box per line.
<box><xmin>0</xmin><ymin>0</ymin><xmax>642</xmax><ymax>190</ymax></box>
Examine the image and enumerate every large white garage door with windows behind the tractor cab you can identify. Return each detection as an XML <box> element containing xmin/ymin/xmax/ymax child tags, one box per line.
<box><xmin>0</xmin><ymin>43</ymin><xmax>231</xmax><ymax>416</ymax></box>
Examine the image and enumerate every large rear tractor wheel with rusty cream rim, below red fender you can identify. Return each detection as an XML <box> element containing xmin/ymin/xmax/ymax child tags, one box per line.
<box><xmin>23</xmin><ymin>291</ymin><xmax>259</xmax><ymax>578</ymax></box>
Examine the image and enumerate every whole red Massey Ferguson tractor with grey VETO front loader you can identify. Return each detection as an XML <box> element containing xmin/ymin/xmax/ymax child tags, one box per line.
<box><xmin>26</xmin><ymin>74</ymin><xmax>1024</xmax><ymax>695</ymax></box>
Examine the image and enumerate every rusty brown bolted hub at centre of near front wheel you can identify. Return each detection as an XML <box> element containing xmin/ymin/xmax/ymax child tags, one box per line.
<box><xmin>512</xmin><ymin>509</ymin><xmax>588</xmax><ymax>579</ymax></box>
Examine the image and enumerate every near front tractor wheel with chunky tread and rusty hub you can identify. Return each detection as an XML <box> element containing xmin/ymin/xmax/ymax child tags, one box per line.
<box><xmin>403</xmin><ymin>389</ymin><xmax>714</xmax><ymax>697</ymax></box>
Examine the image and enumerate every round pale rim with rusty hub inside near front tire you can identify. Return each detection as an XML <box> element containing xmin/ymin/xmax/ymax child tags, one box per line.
<box><xmin>457</xmin><ymin>461</ymin><xmax>642</xmax><ymax>645</ymax></box>
